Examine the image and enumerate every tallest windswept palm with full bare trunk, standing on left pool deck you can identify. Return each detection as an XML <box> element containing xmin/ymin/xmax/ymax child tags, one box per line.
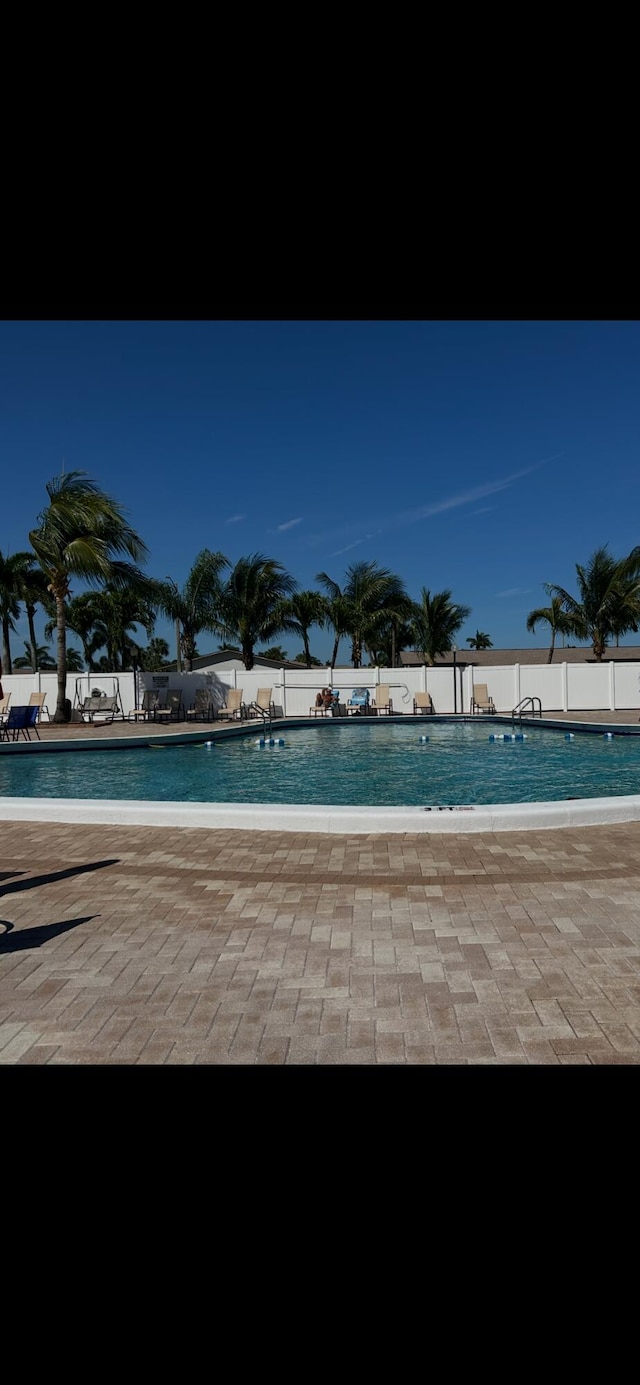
<box><xmin>29</xmin><ymin>471</ymin><xmax>147</xmax><ymax>722</ymax></box>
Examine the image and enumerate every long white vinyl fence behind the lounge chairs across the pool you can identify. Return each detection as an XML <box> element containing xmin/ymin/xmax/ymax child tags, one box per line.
<box><xmin>3</xmin><ymin>661</ymin><xmax>640</xmax><ymax>716</ymax></box>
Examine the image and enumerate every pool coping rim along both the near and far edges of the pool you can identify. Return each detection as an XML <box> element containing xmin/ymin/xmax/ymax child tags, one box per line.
<box><xmin>0</xmin><ymin>715</ymin><xmax>640</xmax><ymax>835</ymax></box>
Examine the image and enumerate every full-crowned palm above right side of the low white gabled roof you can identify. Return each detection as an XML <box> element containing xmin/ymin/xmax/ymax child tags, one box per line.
<box><xmin>216</xmin><ymin>553</ymin><xmax>298</xmax><ymax>669</ymax></box>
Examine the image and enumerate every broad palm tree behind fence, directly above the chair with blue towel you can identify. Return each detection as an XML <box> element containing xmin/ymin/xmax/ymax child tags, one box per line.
<box><xmin>316</xmin><ymin>561</ymin><xmax>411</xmax><ymax>669</ymax></box>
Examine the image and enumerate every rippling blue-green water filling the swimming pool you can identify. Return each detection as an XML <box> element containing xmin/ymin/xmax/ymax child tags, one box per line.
<box><xmin>0</xmin><ymin>722</ymin><xmax>640</xmax><ymax>806</ymax></box>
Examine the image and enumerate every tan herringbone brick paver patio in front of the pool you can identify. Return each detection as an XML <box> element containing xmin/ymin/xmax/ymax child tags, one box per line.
<box><xmin>0</xmin><ymin>823</ymin><xmax>640</xmax><ymax>1065</ymax></box>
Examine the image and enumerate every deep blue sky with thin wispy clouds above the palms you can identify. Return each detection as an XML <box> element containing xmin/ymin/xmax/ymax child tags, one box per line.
<box><xmin>0</xmin><ymin>321</ymin><xmax>640</xmax><ymax>661</ymax></box>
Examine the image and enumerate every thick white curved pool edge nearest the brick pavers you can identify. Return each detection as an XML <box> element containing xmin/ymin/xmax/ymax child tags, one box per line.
<box><xmin>0</xmin><ymin>795</ymin><xmax>640</xmax><ymax>835</ymax></box>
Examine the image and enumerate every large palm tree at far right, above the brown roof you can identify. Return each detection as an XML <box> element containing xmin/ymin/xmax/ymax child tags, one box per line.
<box><xmin>544</xmin><ymin>544</ymin><xmax>640</xmax><ymax>662</ymax></box>
